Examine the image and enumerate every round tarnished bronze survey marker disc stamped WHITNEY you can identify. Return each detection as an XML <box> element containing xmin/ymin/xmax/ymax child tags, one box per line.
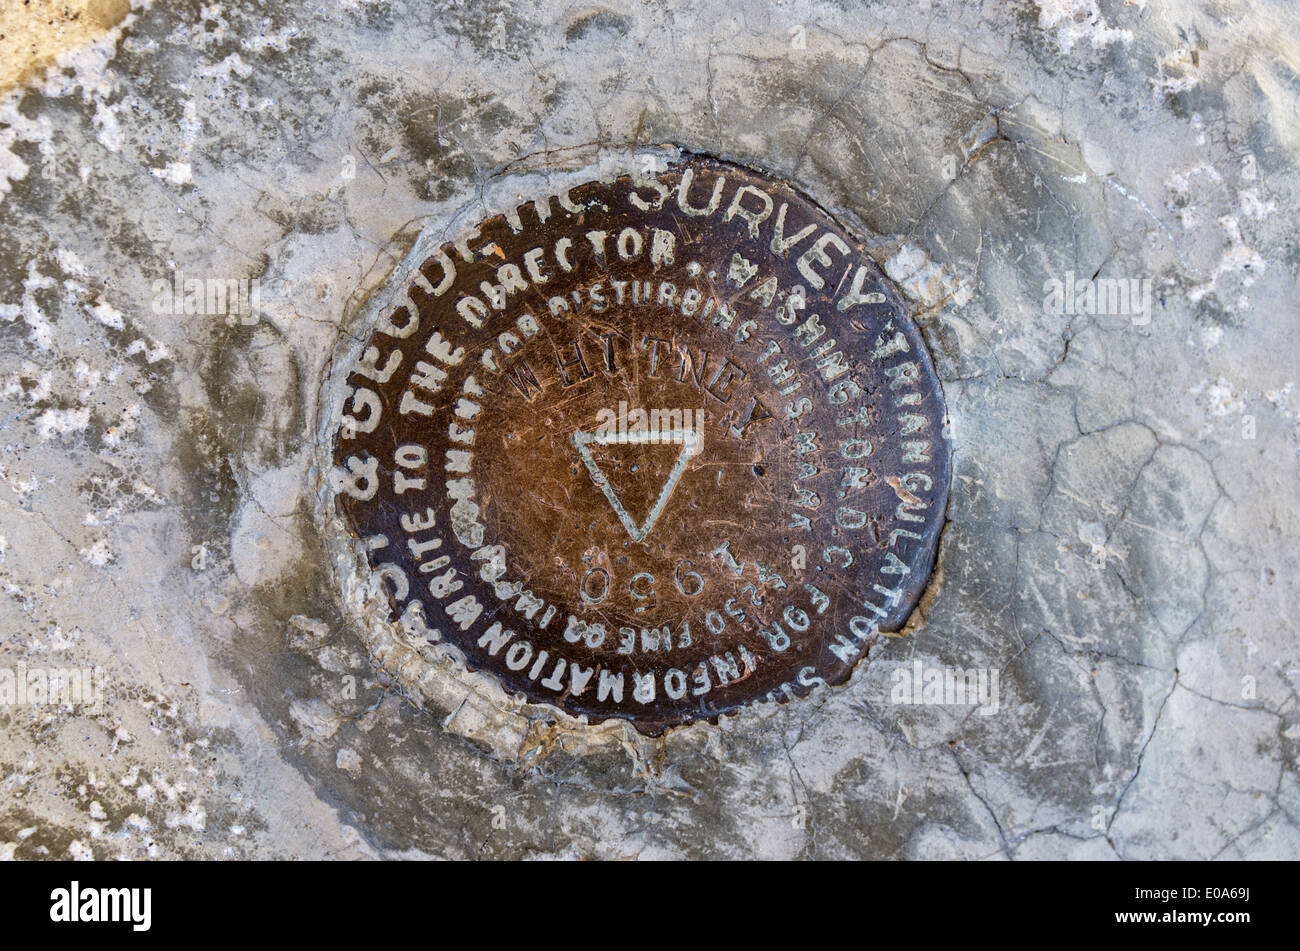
<box><xmin>332</xmin><ymin>156</ymin><xmax>950</xmax><ymax>734</ymax></box>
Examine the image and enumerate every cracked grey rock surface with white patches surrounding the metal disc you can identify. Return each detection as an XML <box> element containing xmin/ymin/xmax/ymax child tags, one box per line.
<box><xmin>0</xmin><ymin>0</ymin><xmax>1300</xmax><ymax>859</ymax></box>
